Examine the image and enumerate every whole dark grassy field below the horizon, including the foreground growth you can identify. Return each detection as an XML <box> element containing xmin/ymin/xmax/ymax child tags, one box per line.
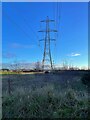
<box><xmin>2</xmin><ymin>71</ymin><xmax>89</xmax><ymax>119</ymax></box>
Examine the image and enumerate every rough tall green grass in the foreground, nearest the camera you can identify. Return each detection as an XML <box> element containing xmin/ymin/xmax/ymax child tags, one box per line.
<box><xmin>3</xmin><ymin>86</ymin><xmax>89</xmax><ymax>118</ymax></box>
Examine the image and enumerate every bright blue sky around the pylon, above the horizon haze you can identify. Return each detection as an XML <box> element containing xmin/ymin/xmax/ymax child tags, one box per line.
<box><xmin>2</xmin><ymin>2</ymin><xmax>88</xmax><ymax>66</ymax></box>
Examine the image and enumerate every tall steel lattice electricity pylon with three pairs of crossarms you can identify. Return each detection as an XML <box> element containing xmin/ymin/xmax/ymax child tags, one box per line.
<box><xmin>39</xmin><ymin>16</ymin><xmax>57</xmax><ymax>70</ymax></box>
